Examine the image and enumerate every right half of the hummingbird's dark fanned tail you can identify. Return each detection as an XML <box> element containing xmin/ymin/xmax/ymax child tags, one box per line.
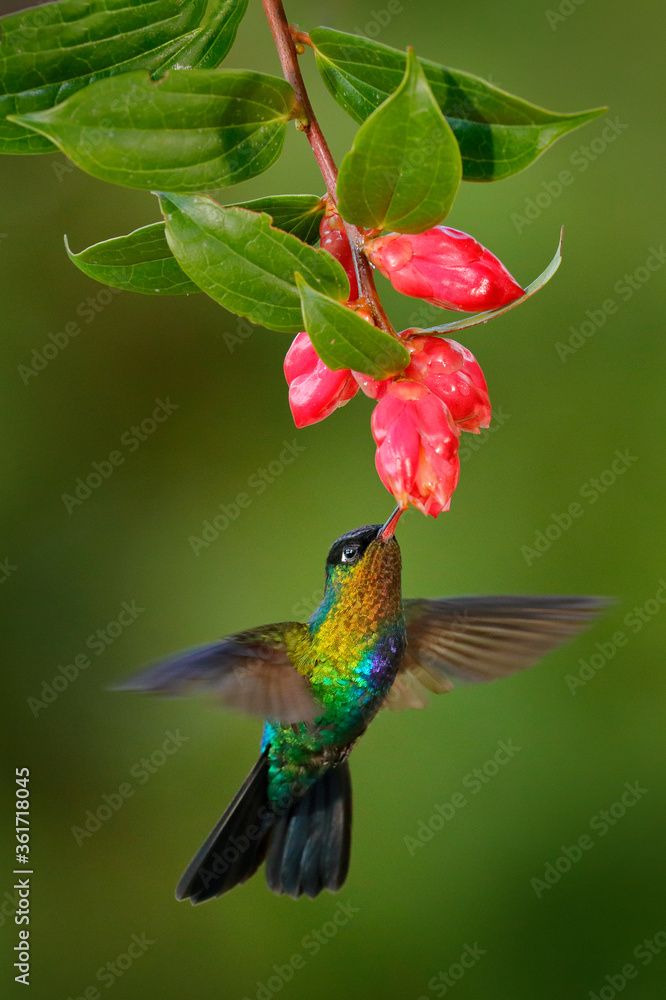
<box><xmin>266</xmin><ymin>761</ymin><xmax>352</xmax><ymax>898</ymax></box>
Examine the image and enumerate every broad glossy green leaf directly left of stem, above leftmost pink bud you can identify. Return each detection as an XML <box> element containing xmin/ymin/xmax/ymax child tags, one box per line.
<box><xmin>160</xmin><ymin>194</ymin><xmax>349</xmax><ymax>333</ymax></box>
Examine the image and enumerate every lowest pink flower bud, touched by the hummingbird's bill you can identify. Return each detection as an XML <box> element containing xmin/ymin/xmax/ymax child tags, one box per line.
<box><xmin>372</xmin><ymin>380</ymin><xmax>460</xmax><ymax>517</ymax></box>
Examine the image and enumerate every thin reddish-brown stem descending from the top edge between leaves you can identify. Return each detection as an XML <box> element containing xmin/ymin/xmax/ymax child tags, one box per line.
<box><xmin>262</xmin><ymin>0</ymin><xmax>396</xmax><ymax>336</ymax></box>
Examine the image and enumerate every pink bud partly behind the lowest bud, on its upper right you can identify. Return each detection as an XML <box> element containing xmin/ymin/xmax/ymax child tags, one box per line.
<box><xmin>400</xmin><ymin>336</ymin><xmax>491</xmax><ymax>434</ymax></box>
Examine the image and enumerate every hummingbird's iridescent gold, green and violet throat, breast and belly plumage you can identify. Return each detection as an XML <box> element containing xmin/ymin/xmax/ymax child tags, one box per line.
<box><xmin>262</xmin><ymin>525</ymin><xmax>406</xmax><ymax>800</ymax></box>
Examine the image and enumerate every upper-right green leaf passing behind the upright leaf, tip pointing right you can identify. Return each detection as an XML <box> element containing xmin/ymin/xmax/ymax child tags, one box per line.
<box><xmin>310</xmin><ymin>28</ymin><xmax>607</xmax><ymax>181</ymax></box>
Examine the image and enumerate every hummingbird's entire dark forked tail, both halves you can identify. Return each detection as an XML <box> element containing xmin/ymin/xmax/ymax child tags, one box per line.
<box><xmin>176</xmin><ymin>750</ymin><xmax>352</xmax><ymax>903</ymax></box>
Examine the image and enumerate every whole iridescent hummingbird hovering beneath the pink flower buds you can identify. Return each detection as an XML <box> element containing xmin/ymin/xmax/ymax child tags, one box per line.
<box><xmin>119</xmin><ymin>507</ymin><xmax>607</xmax><ymax>904</ymax></box>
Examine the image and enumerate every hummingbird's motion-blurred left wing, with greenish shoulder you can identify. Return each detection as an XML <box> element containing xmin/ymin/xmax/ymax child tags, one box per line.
<box><xmin>116</xmin><ymin>622</ymin><xmax>322</xmax><ymax>723</ymax></box>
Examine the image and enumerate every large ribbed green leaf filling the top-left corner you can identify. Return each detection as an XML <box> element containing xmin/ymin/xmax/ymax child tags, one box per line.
<box><xmin>0</xmin><ymin>0</ymin><xmax>248</xmax><ymax>153</ymax></box>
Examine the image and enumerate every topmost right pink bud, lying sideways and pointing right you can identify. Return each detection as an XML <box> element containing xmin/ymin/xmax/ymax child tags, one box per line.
<box><xmin>364</xmin><ymin>226</ymin><xmax>524</xmax><ymax>312</ymax></box>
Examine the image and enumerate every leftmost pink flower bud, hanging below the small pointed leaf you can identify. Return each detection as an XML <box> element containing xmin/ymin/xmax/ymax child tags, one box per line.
<box><xmin>284</xmin><ymin>333</ymin><xmax>358</xmax><ymax>427</ymax></box>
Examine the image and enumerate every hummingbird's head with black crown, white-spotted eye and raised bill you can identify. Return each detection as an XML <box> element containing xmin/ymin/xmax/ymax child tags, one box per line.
<box><xmin>326</xmin><ymin>507</ymin><xmax>402</xmax><ymax>614</ymax></box>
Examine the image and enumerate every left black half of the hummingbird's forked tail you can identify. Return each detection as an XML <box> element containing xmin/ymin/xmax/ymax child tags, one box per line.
<box><xmin>176</xmin><ymin>750</ymin><xmax>275</xmax><ymax>903</ymax></box>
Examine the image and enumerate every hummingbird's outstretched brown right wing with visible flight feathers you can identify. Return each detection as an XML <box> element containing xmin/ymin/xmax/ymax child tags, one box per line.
<box><xmin>384</xmin><ymin>596</ymin><xmax>609</xmax><ymax>710</ymax></box>
